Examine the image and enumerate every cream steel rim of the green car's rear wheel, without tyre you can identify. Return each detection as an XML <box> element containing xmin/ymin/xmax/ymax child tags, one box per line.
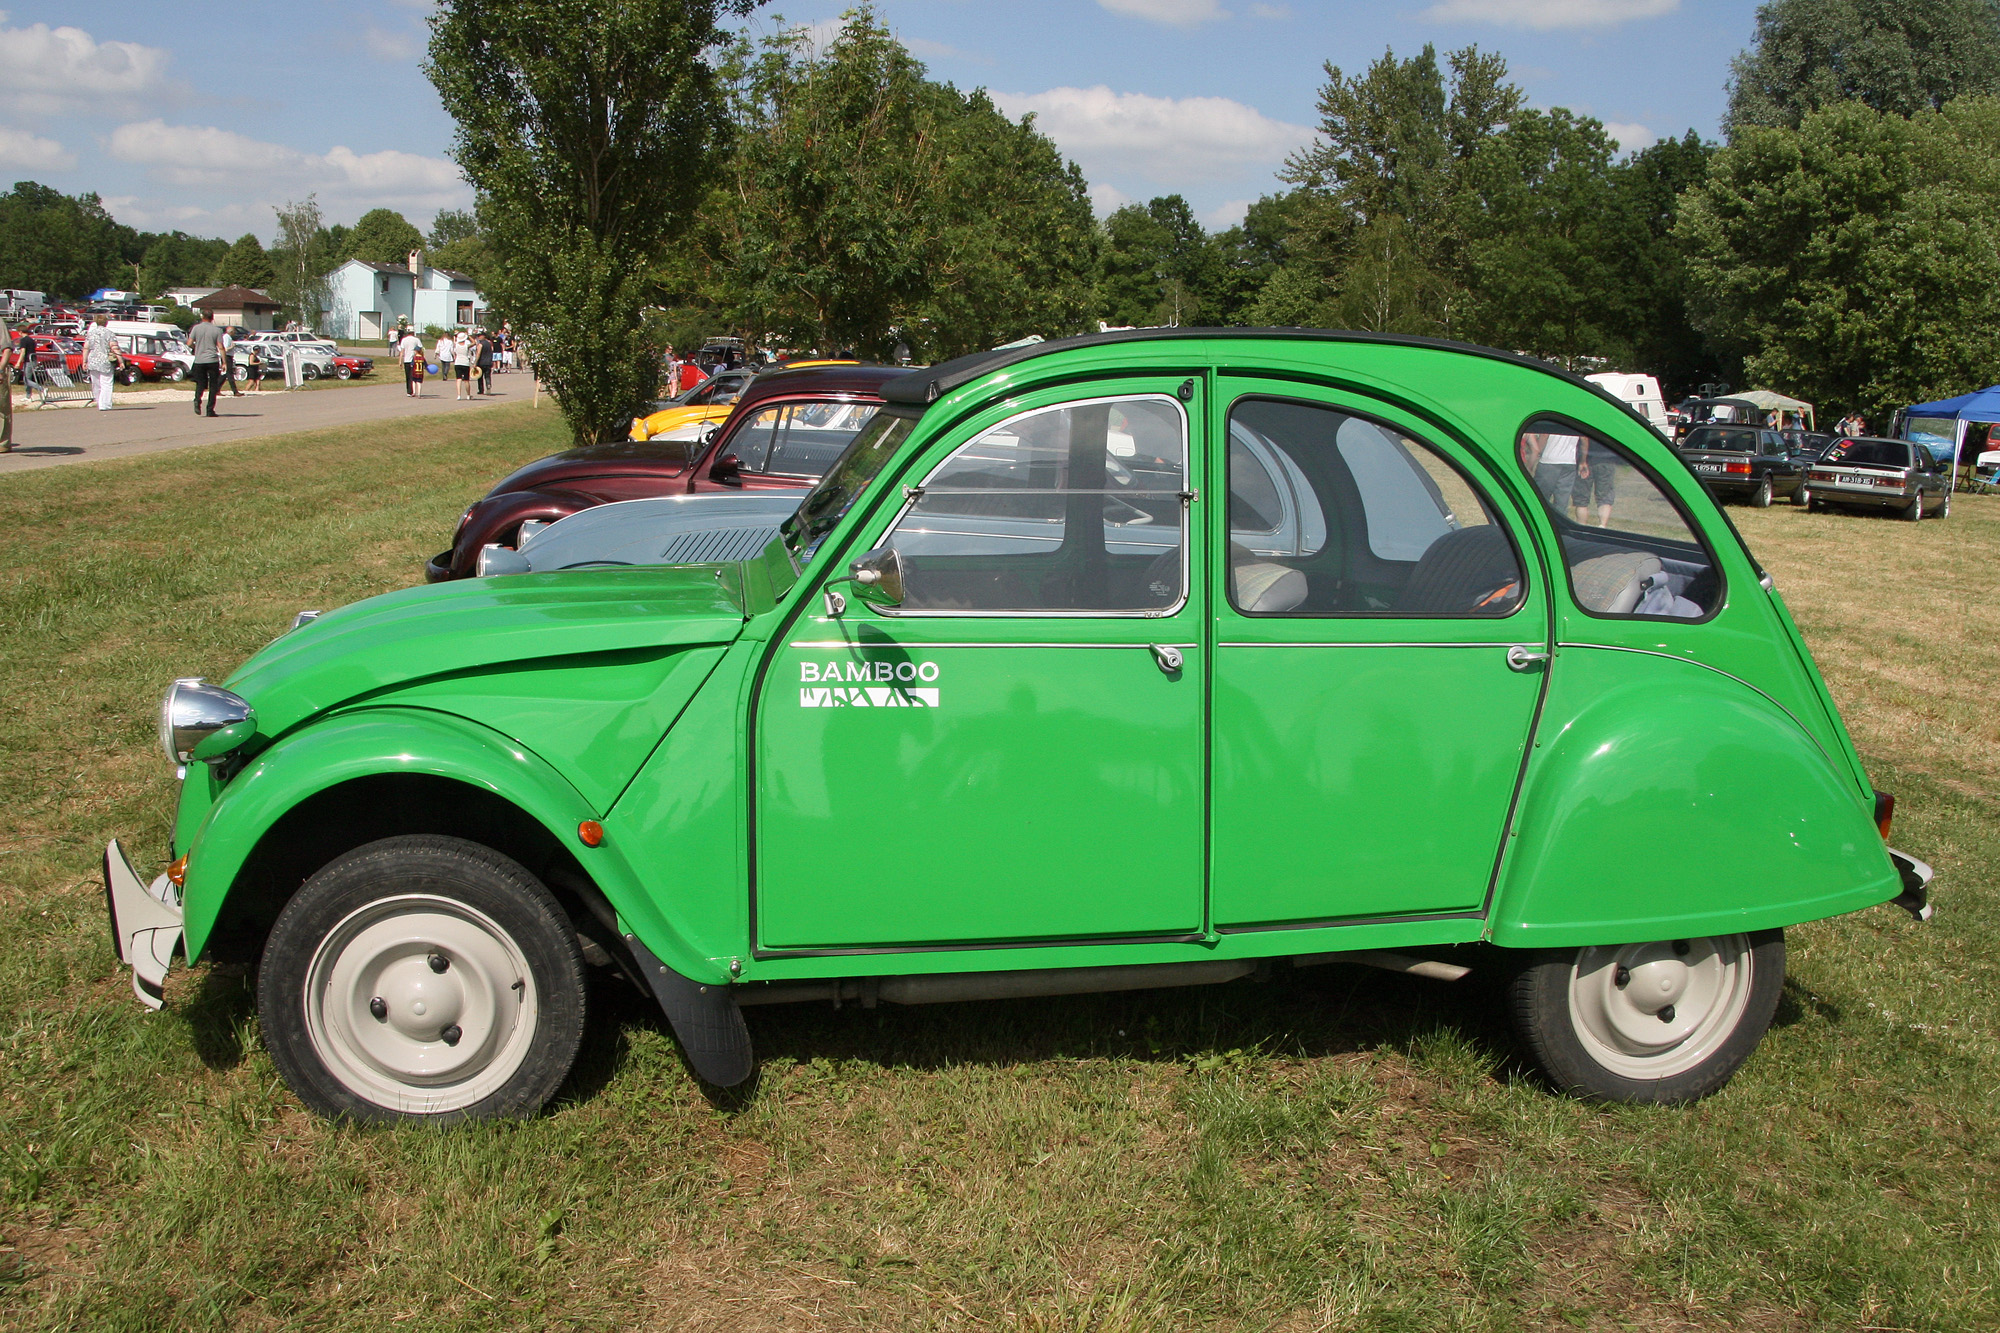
<box><xmin>1570</xmin><ymin>935</ymin><xmax>1756</xmax><ymax>1079</ymax></box>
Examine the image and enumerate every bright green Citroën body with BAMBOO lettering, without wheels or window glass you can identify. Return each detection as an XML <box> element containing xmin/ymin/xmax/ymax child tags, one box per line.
<box><xmin>114</xmin><ymin>330</ymin><xmax>1928</xmax><ymax>1112</ymax></box>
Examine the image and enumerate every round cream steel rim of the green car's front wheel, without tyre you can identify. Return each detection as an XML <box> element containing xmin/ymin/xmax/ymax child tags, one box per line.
<box><xmin>304</xmin><ymin>895</ymin><xmax>540</xmax><ymax>1115</ymax></box>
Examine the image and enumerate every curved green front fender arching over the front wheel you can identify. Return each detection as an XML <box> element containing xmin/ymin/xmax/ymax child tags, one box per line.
<box><xmin>182</xmin><ymin>707</ymin><xmax>728</xmax><ymax>983</ymax></box>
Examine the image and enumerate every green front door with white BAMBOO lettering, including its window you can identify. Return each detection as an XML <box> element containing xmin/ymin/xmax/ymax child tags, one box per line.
<box><xmin>754</xmin><ymin>378</ymin><xmax>1206</xmax><ymax>951</ymax></box>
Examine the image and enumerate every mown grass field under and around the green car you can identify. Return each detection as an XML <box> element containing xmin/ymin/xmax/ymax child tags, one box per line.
<box><xmin>0</xmin><ymin>406</ymin><xmax>2000</xmax><ymax>1331</ymax></box>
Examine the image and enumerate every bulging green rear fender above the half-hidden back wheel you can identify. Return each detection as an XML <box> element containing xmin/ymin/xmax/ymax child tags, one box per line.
<box><xmin>1488</xmin><ymin>646</ymin><xmax>1902</xmax><ymax>947</ymax></box>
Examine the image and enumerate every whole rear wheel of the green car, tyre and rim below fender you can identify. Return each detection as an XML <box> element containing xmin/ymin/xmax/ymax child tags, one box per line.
<box><xmin>1508</xmin><ymin>931</ymin><xmax>1784</xmax><ymax>1105</ymax></box>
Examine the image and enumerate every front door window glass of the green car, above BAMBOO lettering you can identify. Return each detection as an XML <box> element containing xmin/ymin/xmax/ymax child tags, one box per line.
<box><xmin>888</xmin><ymin>394</ymin><xmax>1188</xmax><ymax>614</ymax></box>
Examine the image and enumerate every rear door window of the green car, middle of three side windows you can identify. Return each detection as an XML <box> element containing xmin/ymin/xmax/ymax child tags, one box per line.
<box><xmin>1228</xmin><ymin>398</ymin><xmax>1522</xmax><ymax>616</ymax></box>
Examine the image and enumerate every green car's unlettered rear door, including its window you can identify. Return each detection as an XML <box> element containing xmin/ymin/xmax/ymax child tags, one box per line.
<box><xmin>1208</xmin><ymin>378</ymin><xmax>1544</xmax><ymax>931</ymax></box>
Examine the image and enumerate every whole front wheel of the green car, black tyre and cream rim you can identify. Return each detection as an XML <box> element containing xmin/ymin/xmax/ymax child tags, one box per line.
<box><xmin>256</xmin><ymin>835</ymin><xmax>584</xmax><ymax>1121</ymax></box>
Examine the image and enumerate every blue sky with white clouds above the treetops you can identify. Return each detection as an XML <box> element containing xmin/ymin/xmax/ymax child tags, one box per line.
<box><xmin>0</xmin><ymin>0</ymin><xmax>1756</xmax><ymax>240</ymax></box>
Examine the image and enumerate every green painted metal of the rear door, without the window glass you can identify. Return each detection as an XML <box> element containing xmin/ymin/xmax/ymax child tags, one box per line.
<box><xmin>1210</xmin><ymin>378</ymin><xmax>1548</xmax><ymax>931</ymax></box>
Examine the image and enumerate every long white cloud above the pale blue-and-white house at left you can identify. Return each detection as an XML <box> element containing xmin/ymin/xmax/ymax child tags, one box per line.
<box><xmin>106</xmin><ymin>120</ymin><xmax>472</xmax><ymax>232</ymax></box>
